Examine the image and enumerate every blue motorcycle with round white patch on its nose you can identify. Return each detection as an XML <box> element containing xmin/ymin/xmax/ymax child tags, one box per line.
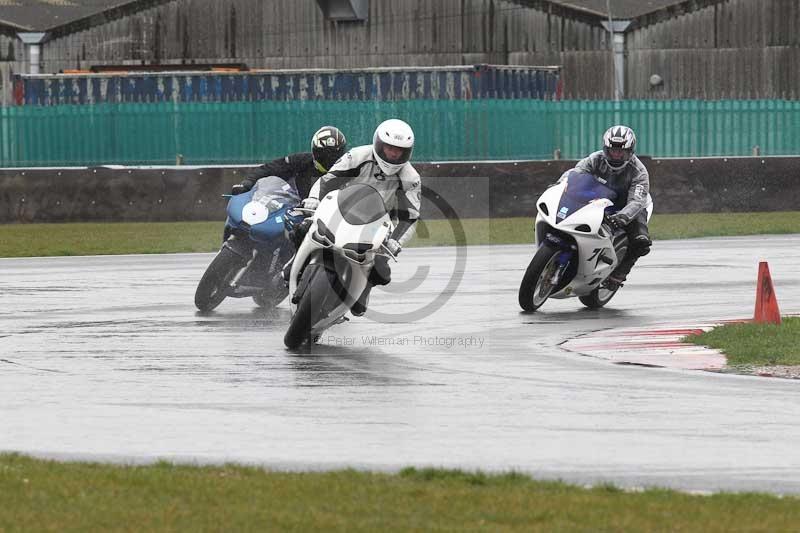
<box><xmin>194</xmin><ymin>176</ymin><xmax>304</xmax><ymax>311</ymax></box>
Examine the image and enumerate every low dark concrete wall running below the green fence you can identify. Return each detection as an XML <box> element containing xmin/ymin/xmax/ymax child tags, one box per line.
<box><xmin>0</xmin><ymin>157</ymin><xmax>800</xmax><ymax>223</ymax></box>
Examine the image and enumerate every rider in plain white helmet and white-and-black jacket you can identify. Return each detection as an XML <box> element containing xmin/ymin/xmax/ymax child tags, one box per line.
<box><xmin>303</xmin><ymin>118</ymin><xmax>422</xmax><ymax>316</ymax></box>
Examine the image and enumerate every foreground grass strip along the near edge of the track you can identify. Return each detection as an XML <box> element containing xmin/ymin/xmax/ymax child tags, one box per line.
<box><xmin>0</xmin><ymin>454</ymin><xmax>800</xmax><ymax>532</ymax></box>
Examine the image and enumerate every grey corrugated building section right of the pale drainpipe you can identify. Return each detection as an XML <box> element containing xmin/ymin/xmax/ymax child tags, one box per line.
<box><xmin>626</xmin><ymin>0</ymin><xmax>800</xmax><ymax>99</ymax></box>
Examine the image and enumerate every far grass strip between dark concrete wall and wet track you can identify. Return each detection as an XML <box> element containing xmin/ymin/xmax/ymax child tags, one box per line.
<box><xmin>0</xmin><ymin>211</ymin><xmax>800</xmax><ymax>257</ymax></box>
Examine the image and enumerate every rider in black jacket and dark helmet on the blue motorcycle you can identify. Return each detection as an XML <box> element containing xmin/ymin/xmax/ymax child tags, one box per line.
<box><xmin>231</xmin><ymin>126</ymin><xmax>347</xmax><ymax>198</ymax></box>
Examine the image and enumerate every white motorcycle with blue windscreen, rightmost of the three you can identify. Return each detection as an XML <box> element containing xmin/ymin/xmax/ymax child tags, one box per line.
<box><xmin>519</xmin><ymin>170</ymin><xmax>653</xmax><ymax>311</ymax></box>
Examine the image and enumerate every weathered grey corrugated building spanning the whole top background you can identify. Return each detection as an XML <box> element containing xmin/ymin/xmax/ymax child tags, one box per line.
<box><xmin>0</xmin><ymin>0</ymin><xmax>800</xmax><ymax>103</ymax></box>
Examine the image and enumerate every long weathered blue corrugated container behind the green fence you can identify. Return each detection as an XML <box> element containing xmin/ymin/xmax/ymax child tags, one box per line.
<box><xmin>14</xmin><ymin>65</ymin><xmax>559</xmax><ymax>105</ymax></box>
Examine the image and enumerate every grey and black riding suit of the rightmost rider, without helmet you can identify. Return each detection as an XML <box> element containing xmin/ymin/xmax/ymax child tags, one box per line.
<box><xmin>575</xmin><ymin>151</ymin><xmax>653</xmax><ymax>282</ymax></box>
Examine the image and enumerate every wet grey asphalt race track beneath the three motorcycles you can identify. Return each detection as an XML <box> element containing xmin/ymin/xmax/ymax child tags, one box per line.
<box><xmin>0</xmin><ymin>236</ymin><xmax>800</xmax><ymax>493</ymax></box>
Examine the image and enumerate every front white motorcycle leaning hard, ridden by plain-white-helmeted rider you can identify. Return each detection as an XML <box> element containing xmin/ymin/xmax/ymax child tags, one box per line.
<box><xmin>283</xmin><ymin>183</ymin><xmax>394</xmax><ymax>349</ymax></box>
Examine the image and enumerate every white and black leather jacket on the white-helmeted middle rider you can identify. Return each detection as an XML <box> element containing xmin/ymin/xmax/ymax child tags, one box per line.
<box><xmin>309</xmin><ymin>144</ymin><xmax>422</xmax><ymax>246</ymax></box>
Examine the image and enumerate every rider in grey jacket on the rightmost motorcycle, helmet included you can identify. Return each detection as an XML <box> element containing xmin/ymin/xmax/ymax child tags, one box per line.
<box><xmin>575</xmin><ymin>125</ymin><xmax>653</xmax><ymax>289</ymax></box>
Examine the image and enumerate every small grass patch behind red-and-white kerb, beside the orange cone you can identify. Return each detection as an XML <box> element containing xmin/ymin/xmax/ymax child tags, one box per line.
<box><xmin>684</xmin><ymin>317</ymin><xmax>800</xmax><ymax>366</ymax></box>
